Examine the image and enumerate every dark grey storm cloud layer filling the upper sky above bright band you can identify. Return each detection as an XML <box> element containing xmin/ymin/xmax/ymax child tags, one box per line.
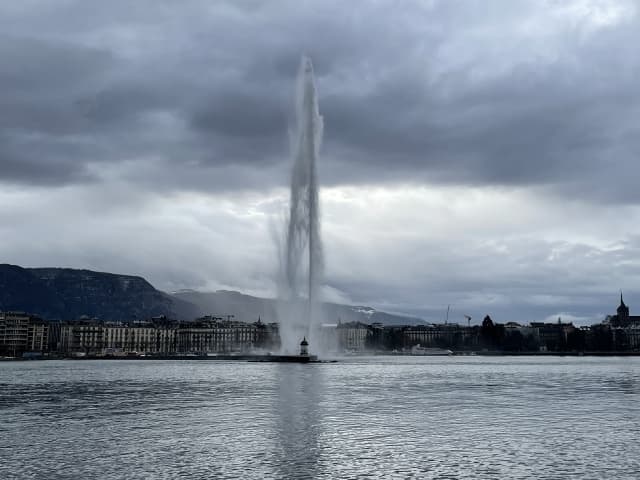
<box><xmin>0</xmin><ymin>2</ymin><xmax>640</xmax><ymax>202</ymax></box>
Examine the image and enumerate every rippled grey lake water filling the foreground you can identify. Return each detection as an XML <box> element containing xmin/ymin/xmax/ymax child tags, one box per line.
<box><xmin>0</xmin><ymin>357</ymin><xmax>640</xmax><ymax>479</ymax></box>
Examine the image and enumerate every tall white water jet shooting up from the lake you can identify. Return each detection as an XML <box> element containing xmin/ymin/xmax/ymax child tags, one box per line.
<box><xmin>278</xmin><ymin>56</ymin><xmax>323</xmax><ymax>354</ymax></box>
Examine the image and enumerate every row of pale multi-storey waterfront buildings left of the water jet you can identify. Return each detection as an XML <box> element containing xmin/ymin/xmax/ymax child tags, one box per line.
<box><xmin>0</xmin><ymin>312</ymin><xmax>279</xmax><ymax>357</ymax></box>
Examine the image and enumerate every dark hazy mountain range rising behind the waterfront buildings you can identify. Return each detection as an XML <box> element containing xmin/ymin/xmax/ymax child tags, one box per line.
<box><xmin>0</xmin><ymin>264</ymin><xmax>424</xmax><ymax>325</ymax></box>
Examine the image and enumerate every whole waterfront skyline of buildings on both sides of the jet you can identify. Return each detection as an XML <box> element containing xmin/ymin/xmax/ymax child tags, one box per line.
<box><xmin>0</xmin><ymin>298</ymin><xmax>640</xmax><ymax>357</ymax></box>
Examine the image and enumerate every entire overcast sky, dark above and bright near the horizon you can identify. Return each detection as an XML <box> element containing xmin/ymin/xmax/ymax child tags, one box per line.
<box><xmin>0</xmin><ymin>0</ymin><xmax>640</xmax><ymax>323</ymax></box>
